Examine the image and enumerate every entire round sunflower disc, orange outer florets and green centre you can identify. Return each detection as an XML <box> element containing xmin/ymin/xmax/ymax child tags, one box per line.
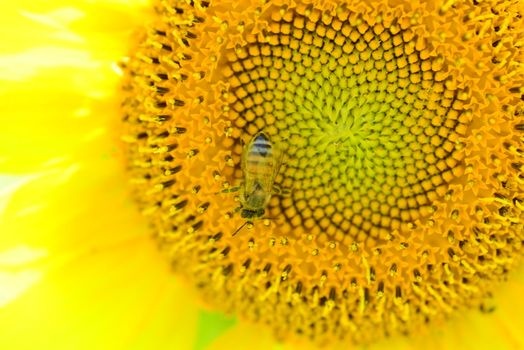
<box><xmin>122</xmin><ymin>0</ymin><xmax>524</xmax><ymax>344</ymax></box>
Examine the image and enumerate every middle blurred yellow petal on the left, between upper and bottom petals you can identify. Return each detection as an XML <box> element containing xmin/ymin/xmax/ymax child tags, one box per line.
<box><xmin>0</xmin><ymin>158</ymin><xmax>135</xmax><ymax>253</ymax></box>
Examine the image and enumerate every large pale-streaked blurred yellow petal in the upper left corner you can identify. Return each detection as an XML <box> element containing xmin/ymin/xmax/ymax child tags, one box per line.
<box><xmin>0</xmin><ymin>1</ymin><xmax>144</xmax><ymax>173</ymax></box>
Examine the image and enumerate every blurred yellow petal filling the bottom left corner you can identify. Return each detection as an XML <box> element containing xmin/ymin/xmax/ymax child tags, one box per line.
<box><xmin>0</xmin><ymin>237</ymin><xmax>197</xmax><ymax>349</ymax></box>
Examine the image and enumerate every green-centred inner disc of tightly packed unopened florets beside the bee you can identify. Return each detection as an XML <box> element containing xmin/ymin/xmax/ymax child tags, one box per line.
<box><xmin>225</xmin><ymin>10</ymin><xmax>467</xmax><ymax>241</ymax></box>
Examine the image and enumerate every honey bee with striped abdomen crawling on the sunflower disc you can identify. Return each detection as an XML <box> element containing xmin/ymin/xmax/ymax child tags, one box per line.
<box><xmin>224</xmin><ymin>132</ymin><xmax>283</xmax><ymax>235</ymax></box>
